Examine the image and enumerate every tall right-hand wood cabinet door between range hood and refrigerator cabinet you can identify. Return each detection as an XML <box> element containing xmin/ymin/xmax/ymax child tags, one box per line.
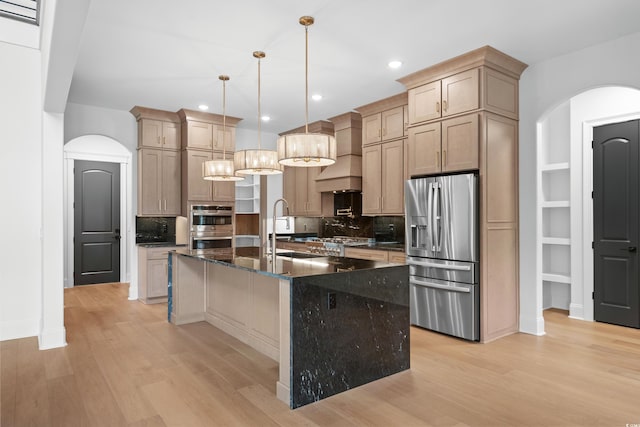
<box><xmin>381</xmin><ymin>140</ymin><xmax>404</xmax><ymax>215</ymax></box>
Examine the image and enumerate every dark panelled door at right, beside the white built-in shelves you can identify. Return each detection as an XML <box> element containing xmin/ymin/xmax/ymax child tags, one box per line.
<box><xmin>593</xmin><ymin>120</ymin><xmax>640</xmax><ymax>328</ymax></box>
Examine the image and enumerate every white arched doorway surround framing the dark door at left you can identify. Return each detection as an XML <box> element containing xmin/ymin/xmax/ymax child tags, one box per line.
<box><xmin>64</xmin><ymin>135</ymin><xmax>138</xmax><ymax>299</ymax></box>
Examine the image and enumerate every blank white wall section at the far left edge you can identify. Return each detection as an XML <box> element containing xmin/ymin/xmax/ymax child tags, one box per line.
<box><xmin>0</xmin><ymin>40</ymin><xmax>42</xmax><ymax>340</ymax></box>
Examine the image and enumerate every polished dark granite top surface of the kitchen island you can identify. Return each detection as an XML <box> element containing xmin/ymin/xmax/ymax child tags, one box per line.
<box><xmin>175</xmin><ymin>248</ymin><xmax>395</xmax><ymax>280</ymax></box>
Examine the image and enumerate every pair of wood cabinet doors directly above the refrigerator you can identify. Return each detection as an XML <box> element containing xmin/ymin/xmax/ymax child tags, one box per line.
<box><xmin>405</xmin><ymin>114</ymin><xmax>480</xmax><ymax>177</ymax></box>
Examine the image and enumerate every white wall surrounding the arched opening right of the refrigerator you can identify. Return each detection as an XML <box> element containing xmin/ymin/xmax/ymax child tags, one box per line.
<box><xmin>519</xmin><ymin>33</ymin><xmax>640</xmax><ymax>334</ymax></box>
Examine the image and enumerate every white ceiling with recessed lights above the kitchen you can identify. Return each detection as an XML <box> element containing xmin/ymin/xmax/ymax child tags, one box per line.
<box><xmin>69</xmin><ymin>0</ymin><xmax>640</xmax><ymax>133</ymax></box>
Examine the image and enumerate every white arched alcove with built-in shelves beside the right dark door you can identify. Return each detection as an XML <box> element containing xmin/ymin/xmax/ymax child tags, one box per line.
<box><xmin>536</xmin><ymin>87</ymin><xmax>640</xmax><ymax>334</ymax></box>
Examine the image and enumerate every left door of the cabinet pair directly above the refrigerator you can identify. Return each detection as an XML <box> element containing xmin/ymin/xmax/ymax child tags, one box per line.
<box><xmin>405</xmin><ymin>123</ymin><xmax>440</xmax><ymax>177</ymax></box>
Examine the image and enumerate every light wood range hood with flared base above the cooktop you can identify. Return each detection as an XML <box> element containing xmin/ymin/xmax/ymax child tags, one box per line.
<box><xmin>316</xmin><ymin>112</ymin><xmax>362</xmax><ymax>192</ymax></box>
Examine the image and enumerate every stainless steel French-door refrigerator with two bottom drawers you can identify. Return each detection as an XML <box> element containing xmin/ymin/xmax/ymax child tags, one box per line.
<box><xmin>405</xmin><ymin>174</ymin><xmax>480</xmax><ymax>341</ymax></box>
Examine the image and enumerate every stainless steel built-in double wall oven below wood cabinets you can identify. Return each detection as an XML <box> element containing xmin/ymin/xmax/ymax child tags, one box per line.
<box><xmin>189</xmin><ymin>205</ymin><xmax>233</xmax><ymax>257</ymax></box>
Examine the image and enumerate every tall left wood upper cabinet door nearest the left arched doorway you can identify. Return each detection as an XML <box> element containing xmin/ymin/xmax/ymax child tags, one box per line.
<box><xmin>138</xmin><ymin>148</ymin><xmax>162</xmax><ymax>215</ymax></box>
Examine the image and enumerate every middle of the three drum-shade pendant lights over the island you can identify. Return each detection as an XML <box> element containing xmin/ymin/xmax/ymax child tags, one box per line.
<box><xmin>233</xmin><ymin>51</ymin><xmax>282</xmax><ymax>175</ymax></box>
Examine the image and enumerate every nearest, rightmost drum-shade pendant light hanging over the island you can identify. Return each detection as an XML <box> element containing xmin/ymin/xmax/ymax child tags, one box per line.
<box><xmin>278</xmin><ymin>16</ymin><xmax>336</xmax><ymax>167</ymax></box>
